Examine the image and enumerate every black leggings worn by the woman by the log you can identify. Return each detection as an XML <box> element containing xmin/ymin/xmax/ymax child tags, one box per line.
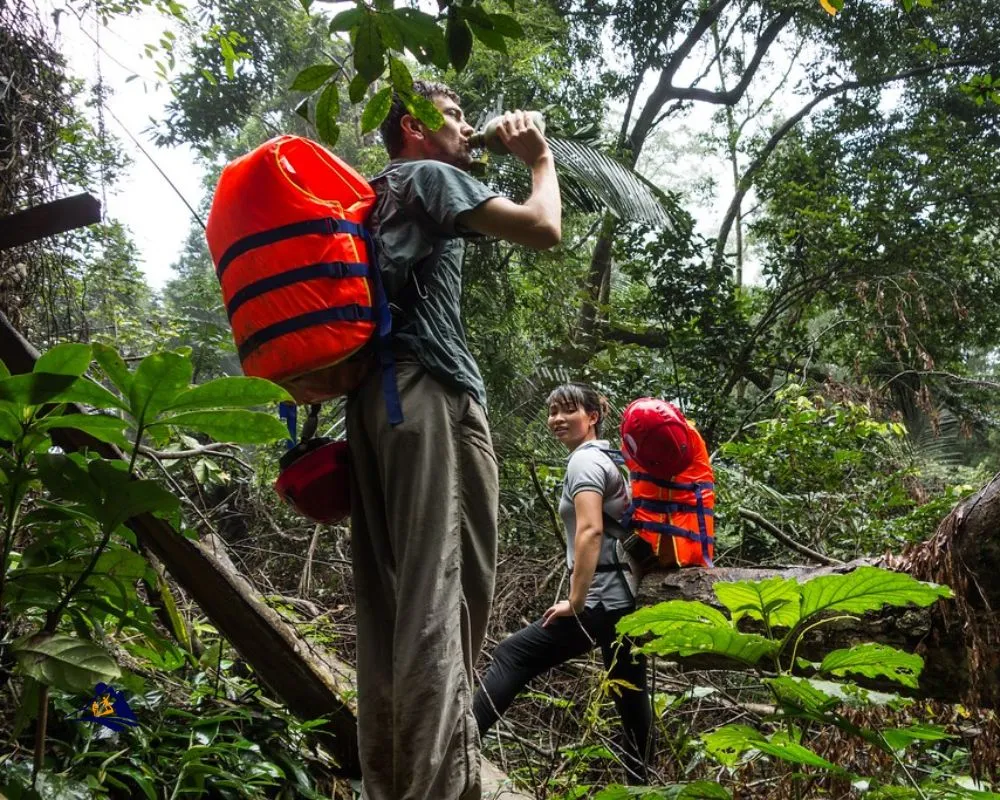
<box><xmin>472</xmin><ymin>605</ymin><xmax>653</xmax><ymax>783</ymax></box>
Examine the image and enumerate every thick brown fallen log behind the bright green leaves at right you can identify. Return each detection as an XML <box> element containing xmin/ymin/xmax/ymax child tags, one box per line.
<box><xmin>638</xmin><ymin>475</ymin><xmax>1000</xmax><ymax>709</ymax></box>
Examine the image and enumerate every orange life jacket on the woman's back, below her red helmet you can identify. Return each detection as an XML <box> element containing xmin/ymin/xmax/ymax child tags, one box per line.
<box><xmin>608</xmin><ymin>423</ymin><xmax>715</xmax><ymax>567</ymax></box>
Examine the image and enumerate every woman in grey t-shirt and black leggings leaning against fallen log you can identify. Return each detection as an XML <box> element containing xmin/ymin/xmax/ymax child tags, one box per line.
<box><xmin>473</xmin><ymin>383</ymin><xmax>652</xmax><ymax>783</ymax></box>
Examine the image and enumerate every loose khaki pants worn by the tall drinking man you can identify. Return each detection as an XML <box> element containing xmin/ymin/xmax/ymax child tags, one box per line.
<box><xmin>347</xmin><ymin>362</ymin><xmax>499</xmax><ymax>800</ymax></box>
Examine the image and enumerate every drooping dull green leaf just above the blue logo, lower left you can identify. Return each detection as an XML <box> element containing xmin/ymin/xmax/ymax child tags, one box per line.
<box><xmin>12</xmin><ymin>633</ymin><xmax>121</xmax><ymax>692</ymax></box>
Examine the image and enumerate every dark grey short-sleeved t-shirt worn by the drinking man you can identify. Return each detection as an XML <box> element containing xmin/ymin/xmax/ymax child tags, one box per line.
<box><xmin>369</xmin><ymin>159</ymin><xmax>497</xmax><ymax>406</ymax></box>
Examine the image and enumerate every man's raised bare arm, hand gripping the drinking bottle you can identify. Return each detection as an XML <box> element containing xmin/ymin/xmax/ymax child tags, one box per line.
<box><xmin>458</xmin><ymin>111</ymin><xmax>562</xmax><ymax>250</ymax></box>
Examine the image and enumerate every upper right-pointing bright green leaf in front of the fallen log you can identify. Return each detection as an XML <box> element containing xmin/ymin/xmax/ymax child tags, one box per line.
<box><xmin>801</xmin><ymin>567</ymin><xmax>952</xmax><ymax>620</ymax></box>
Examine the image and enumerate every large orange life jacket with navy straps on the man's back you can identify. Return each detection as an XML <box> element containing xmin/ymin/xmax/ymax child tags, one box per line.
<box><xmin>206</xmin><ymin>136</ymin><xmax>395</xmax><ymax>416</ymax></box>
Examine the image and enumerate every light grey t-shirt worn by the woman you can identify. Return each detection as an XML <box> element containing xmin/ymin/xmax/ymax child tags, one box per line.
<box><xmin>559</xmin><ymin>439</ymin><xmax>635</xmax><ymax>611</ymax></box>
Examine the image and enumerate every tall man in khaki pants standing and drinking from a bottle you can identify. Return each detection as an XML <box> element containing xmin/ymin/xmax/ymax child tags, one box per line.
<box><xmin>347</xmin><ymin>76</ymin><xmax>561</xmax><ymax>800</ymax></box>
